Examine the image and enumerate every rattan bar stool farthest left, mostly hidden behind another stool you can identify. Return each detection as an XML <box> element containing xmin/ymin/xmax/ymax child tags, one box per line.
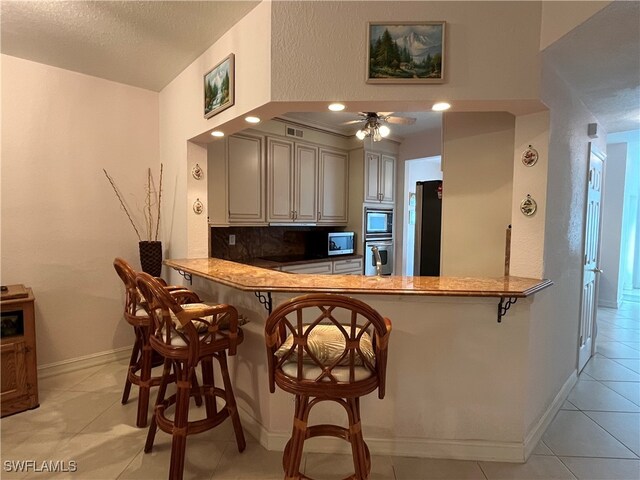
<box><xmin>113</xmin><ymin>258</ymin><xmax>202</xmax><ymax>427</ymax></box>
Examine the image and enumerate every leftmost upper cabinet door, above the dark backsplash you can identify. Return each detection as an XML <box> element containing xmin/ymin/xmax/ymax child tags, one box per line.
<box><xmin>226</xmin><ymin>134</ymin><xmax>266</xmax><ymax>225</ymax></box>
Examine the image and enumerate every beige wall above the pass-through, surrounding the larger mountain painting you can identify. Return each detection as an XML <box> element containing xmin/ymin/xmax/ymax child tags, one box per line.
<box><xmin>271</xmin><ymin>1</ymin><xmax>541</xmax><ymax>106</ymax></box>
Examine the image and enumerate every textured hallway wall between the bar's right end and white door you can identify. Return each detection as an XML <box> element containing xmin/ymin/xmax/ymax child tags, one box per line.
<box><xmin>525</xmin><ymin>61</ymin><xmax>606</xmax><ymax>436</ymax></box>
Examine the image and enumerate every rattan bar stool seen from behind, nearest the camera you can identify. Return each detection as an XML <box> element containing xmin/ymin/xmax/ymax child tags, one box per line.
<box><xmin>265</xmin><ymin>294</ymin><xmax>391</xmax><ymax>480</ymax></box>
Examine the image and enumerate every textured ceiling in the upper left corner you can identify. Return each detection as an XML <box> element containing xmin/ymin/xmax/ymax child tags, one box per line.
<box><xmin>0</xmin><ymin>0</ymin><xmax>259</xmax><ymax>91</ymax></box>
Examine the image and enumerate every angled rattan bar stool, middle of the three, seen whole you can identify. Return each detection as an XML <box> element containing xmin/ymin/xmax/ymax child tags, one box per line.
<box><xmin>136</xmin><ymin>273</ymin><xmax>246</xmax><ymax>480</ymax></box>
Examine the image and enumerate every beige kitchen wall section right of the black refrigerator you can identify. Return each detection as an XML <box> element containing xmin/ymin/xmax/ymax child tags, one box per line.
<box><xmin>440</xmin><ymin>112</ymin><xmax>515</xmax><ymax>277</ymax></box>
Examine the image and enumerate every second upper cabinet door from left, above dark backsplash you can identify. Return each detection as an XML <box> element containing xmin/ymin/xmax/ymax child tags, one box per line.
<box><xmin>267</xmin><ymin>138</ymin><xmax>295</xmax><ymax>222</ymax></box>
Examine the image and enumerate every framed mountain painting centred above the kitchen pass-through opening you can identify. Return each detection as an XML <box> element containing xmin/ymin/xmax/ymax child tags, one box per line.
<box><xmin>367</xmin><ymin>22</ymin><xmax>445</xmax><ymax>83</ymax></box>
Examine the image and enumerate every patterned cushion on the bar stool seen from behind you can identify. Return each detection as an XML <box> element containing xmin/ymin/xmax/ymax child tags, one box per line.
<box><xmin>275</xmin><ymin>325</ymin><xmax>376</xmax><ymax>368</ymax></box>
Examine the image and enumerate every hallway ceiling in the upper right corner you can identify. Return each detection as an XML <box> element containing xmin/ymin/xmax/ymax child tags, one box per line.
<box><xmin>544</xmin><ymin>1</ymin><xmax>640</xmax><ymax>133</ymax></box>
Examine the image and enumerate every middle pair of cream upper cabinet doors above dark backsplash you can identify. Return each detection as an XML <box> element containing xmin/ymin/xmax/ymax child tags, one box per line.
<box><xmin>267</xmin><ymin>137</ymin><xmax>318</xmax><ymax>223</ymax></box>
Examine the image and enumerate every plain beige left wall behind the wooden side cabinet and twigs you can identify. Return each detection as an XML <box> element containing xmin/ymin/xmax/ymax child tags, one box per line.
<box><xmin>0</xmin><ymin>55</ymin><xmax>159</xmax><ymax>366</ymax></box>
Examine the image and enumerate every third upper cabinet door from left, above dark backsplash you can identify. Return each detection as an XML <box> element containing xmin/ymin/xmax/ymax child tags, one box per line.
<box><xmin>293</xmin><ymin>143</ymin><xmax>318</xmax><ymax>223</ymax></box>
